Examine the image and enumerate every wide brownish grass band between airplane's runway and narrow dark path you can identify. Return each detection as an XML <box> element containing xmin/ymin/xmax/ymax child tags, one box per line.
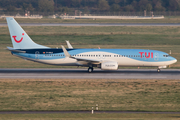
<box><xmin>0</xmin><ymin>79</ymin><xmax>180</xmax><ymax>111</ymax></box>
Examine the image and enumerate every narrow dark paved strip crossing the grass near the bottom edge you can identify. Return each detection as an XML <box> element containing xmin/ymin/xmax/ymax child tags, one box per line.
<box><xmin>0</xmin><ymin>110</ymin><xmax>180</xmax><ymax>114</ymax></box>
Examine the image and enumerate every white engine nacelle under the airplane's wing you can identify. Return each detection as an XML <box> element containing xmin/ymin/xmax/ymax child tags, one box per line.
<box><xmin>101</xmin><ymin>61</ymin><xmax>118</xmax><ymax>70</ymax></box>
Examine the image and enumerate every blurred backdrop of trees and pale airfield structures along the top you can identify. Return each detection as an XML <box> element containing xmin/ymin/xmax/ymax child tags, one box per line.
<box><xmin>0</xmin><ymin>0</ymin><xmax>180</xmax><ymax>19</ymax></box>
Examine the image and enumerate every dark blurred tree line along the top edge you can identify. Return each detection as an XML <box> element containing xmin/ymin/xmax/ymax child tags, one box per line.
<box><xmin>0</xmin><ymin>0</ymin><xmax>180</xmax><ymax>13</ymax></box>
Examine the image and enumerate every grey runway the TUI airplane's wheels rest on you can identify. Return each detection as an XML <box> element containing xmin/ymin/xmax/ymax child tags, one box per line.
<box><xmin>0</xmin><ymin>69</ymin><xmax>180</xmax><ymax>79</ymax></box>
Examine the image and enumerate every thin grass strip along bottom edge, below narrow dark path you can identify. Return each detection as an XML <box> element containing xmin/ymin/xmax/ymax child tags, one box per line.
<box><xmin>0</xmin><ymin>113</ymin><xmax>180</xmax><ymax>120</ymax></box>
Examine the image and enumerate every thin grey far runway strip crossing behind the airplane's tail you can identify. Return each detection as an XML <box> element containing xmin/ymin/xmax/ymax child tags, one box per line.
<box><xmin>0</xmin><ymin>23</ymin><xmax>180</xmax><ymax>26</ymax></box>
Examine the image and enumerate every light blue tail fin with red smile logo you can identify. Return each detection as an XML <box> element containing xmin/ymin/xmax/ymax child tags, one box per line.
<box><xmin>6</xmin><ymin>17</ymin><xmax>48</xmax><ymax>49</ymax></box>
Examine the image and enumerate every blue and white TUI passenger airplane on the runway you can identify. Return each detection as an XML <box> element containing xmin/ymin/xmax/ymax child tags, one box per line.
<box><xmin>6</xmin><ymin>17</ymin><xmax>177</xmax><ymax>73</ymax></box>
